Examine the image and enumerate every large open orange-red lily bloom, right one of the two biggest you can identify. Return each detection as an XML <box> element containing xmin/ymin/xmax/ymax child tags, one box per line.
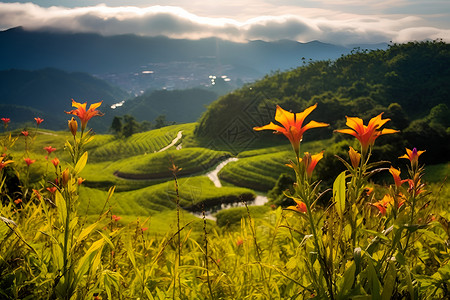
<box><xmin>335</xmin><ymin>113</ymin><xmax>399</xmax><ymax>153</ymax></box>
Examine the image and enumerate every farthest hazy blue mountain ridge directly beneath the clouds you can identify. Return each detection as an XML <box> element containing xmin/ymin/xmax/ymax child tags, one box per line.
<box><xmin>0</xmin><ymin>27</ymin><xmax>387</xmax><ymax>92</ymax></box>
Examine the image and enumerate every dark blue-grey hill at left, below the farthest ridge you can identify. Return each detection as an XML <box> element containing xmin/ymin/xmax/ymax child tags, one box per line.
<box><xmin>0</xmin><ymin>68</ymin><xmax>129</xmax><ymax>129</ymax></box>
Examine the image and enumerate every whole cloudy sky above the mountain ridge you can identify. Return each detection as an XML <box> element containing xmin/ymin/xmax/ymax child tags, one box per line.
<box><xmin>0</xmin><ymin>0</ymin><xmax>450</xmax><ymax>45</ymax></box>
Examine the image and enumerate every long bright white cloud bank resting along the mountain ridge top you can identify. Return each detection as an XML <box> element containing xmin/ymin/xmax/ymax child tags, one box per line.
<box><xmin>0</xmin><ymin>0</ymin><xmax>450</xmax><ymax>44</ymax></box>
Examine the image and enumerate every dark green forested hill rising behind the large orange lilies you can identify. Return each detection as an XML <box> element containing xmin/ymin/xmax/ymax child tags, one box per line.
<box><xmin>196</xmin><ymin>41</ymin><xmax>450</xmax><ymax>160</ymax></box>
